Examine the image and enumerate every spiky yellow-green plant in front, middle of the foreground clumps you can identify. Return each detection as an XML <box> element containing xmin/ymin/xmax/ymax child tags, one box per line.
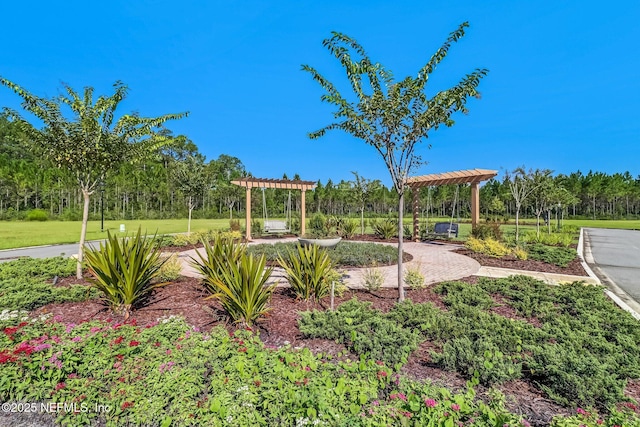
<box><xmin>207</xmin><ymin>253</ymin><xmax>277</xmax><ymax>327</ymax></box>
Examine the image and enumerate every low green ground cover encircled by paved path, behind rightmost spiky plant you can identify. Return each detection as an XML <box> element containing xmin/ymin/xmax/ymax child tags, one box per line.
<box><xmin>247</xmin><ymin>241</ymin><xmax>398</xmax><ymax>267</ymax></box>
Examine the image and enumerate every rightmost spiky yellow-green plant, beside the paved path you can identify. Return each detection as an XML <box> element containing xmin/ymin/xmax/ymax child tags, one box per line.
<box><xmin>278</xmin><ymin>245</ymin><xmax>334</xmax><ymax>301</ymax></box>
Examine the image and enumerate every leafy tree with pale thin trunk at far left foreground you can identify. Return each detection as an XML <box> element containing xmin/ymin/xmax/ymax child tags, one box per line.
<box><xmin>0</xmin><ymin>77</ymin><xmax>187</xmax><ymax>278</ymax></box>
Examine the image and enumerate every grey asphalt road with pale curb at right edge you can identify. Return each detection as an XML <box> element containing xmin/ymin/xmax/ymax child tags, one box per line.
<box><xmin>584</xmin><ymin>228</ymin><xmax>640</xmax><ymax>313</ymax></box>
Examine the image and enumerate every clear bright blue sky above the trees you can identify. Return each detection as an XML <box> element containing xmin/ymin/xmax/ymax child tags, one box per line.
<box><xmin>0</xmin><ymin>0</ymin><xmax>640</xmax><ymax>184</ymax></box>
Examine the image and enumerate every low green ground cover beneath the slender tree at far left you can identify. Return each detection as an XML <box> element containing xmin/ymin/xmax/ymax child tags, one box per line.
<box><xmin>0</xmin><ymin>257</ymin><xmax>98</xmax><ymax>311</ymax></box>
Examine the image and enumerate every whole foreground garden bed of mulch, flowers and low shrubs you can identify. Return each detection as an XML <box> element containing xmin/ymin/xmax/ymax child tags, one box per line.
<box><xmin>0</xmin><ymin>241</ymin><xmax>640</xmax><ymax>427</ymax></box>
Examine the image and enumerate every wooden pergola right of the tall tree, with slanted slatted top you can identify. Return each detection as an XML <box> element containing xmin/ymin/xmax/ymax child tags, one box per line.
<box><xmin>405</xmin><ymin>169</ymin><xmax>498</xmax><ymax>240</ymax></box>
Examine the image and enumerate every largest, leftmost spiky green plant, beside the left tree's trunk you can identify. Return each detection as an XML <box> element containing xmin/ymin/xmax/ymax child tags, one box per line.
<box><xmin>86</xmin><ymin>229</ymin><xmax>165</xmax><ymax>320</ymax></box>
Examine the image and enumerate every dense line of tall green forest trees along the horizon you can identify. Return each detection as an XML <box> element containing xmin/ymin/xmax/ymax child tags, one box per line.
<box><xmin>0</xmin><ymin>115</ymin><xmax>640</xmax><ymax>220</ymax></box>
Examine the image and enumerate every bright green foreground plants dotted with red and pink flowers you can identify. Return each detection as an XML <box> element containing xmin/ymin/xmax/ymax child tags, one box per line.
<box><xmin>0</xmin><ymin>318</ymin><xmax>525</xmax><ymax>426</ymax></box>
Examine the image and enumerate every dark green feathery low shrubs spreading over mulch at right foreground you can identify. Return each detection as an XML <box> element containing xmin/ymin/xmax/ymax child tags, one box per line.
<box><xmin>300</xmin><ymin>276</ymin><xmax>640</xmax><ymax>409</ymax></box>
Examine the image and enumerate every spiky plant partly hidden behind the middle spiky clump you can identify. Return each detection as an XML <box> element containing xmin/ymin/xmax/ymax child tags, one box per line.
<box><xmin>191</xmin><ymin>235</ymin><xmax>246</xmax><ymax>294</ymax></box>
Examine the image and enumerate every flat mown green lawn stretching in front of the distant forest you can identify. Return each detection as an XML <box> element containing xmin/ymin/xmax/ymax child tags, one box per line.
<box><xmin>0</xmin><ymin>217</ymin><xmax>640</xmax><ymax>249</ymax></box>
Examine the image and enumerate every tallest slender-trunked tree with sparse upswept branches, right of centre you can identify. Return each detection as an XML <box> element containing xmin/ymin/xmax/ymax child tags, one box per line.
<box><xmin>302</xmin><ymin>22</ymin><xmax>487</xmax><ymax>301</ymax></box>
